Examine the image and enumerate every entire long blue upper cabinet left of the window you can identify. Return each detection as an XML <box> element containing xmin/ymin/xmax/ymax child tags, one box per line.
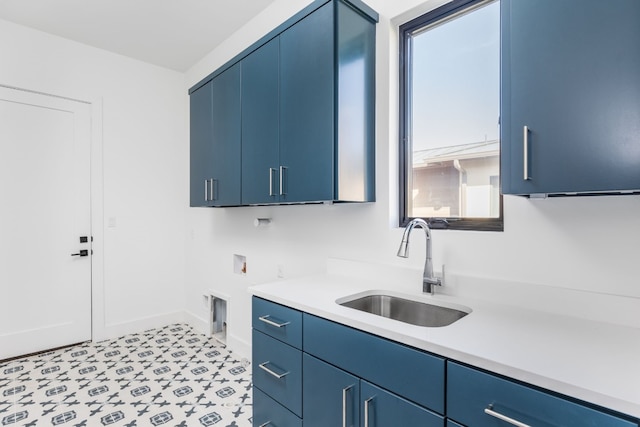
<box><xmin>190</xmin><ymin>0</ymin><xmax>378</xmax><ymax>206</ymax></box>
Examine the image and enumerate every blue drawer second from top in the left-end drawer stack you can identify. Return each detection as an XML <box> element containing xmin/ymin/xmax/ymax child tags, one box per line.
<box><xmin>253</xmin><ymin>330</ymin><xmax>302</xmax><ymax>417</ymax></box>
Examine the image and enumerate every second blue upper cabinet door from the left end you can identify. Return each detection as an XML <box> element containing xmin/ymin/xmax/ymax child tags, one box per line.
<box><xmin>209</xmin><ymin>64</ymin><xmax>241</xmax><ymax>206</ymax></box>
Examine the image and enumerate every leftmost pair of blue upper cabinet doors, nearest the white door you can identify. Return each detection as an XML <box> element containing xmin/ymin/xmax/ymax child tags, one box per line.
<box><xmin>190</xmin><ymin>64</ymin><xmax>241</xmax><ymax>206</ymax></box>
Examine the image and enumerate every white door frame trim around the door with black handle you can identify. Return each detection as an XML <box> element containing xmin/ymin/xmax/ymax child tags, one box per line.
<box><xmin>0</xmin><ymin>82</ymin><xmax>108</xmax><ymax>342</ymax></box>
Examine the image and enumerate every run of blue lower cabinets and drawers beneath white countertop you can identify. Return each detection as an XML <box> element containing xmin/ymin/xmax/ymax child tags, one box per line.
<box><xmin>253</xmin><ymin>298</ymin><xmax>639</xmax><ymax>427</ymax></box>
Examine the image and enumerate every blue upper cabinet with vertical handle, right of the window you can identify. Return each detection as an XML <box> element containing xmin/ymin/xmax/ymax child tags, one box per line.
<box><xmin>501</xmin><ymin>0</ymin><xmax>640</xmax><ymax>195</ymax></box>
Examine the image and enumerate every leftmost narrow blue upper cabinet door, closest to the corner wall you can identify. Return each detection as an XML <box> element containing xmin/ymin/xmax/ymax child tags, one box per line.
<box><xmin>189</xmin><ymin>82</ymin><xmax>213</xmax><ymax>207</ymax></box>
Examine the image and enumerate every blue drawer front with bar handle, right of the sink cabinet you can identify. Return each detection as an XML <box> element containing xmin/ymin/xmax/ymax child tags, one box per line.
<box><xmin>447</xmin><ymin>362</ymin><xmax>638</xmax><ymax>427</ymax></box>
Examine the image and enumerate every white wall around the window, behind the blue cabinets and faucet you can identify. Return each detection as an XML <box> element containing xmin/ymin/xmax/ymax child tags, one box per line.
<box><xmin>185</xmin><ymin>0</ymin><xmax>640</xmax><ymax>360</ymax></box>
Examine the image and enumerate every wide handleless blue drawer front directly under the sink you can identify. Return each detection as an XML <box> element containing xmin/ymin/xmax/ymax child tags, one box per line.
<box><xmin>303</xmin><ymin>314</ymin><xmax>445</xmax><ymax>414</ymax></box>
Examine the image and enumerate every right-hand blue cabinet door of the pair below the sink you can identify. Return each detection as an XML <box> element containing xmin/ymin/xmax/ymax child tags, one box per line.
<box><xmin>360</xmin><ymin>380</ymin><xmax>444</xmax><ymax>427</ymax></box>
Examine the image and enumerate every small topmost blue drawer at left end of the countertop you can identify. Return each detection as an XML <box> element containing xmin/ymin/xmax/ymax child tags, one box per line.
<box><xmin>252</xmin><ymin>297</ymin><xmax>302</xmax><ymax>349</ymax></box>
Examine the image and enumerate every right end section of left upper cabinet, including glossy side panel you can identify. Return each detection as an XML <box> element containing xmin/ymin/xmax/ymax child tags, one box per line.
<box><xmin>280</xmin><ymin>1</ymin><xmax>375</xmax><ymax>202</ymax></box>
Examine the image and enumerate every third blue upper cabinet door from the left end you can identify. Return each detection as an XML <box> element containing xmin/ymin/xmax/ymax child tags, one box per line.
<box><xmin>242</xmin><ymin>37</ymin><xmax>280</xmax><ymax>205</ymax></box>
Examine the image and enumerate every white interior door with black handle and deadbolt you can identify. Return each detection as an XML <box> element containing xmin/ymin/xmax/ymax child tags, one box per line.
<box><xmin>0</xmin><ymin>87</ymin><xmax>91</xmax><ymax>360</ymax></box>
